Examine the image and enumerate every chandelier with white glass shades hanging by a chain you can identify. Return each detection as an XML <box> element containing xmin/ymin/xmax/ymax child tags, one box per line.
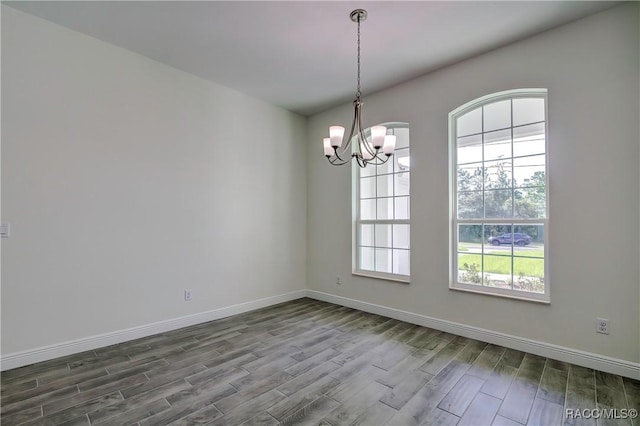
<box><xmin>322</xmin><ymin>9</ymin><xmax>396</xmax><ymax>167</ymax></box>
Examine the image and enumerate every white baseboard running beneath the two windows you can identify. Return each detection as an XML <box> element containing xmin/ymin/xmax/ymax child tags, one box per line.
<box><xmin>307</xmin><ymin>290</ymin><xmax>640</xmax><ymax>380</ymax></box>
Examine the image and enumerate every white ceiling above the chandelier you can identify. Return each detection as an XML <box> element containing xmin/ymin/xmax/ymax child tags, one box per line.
<box><xmin>5</xmin><ymin>1</ymin><xmax>620</xmax><ymax>115</ymax></box>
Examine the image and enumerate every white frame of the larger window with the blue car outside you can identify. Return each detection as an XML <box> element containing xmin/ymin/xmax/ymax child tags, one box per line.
<box><xmin>449</xmin><ymin>88</ymin><xmax>551</xmax><ymax>304</ymax></box>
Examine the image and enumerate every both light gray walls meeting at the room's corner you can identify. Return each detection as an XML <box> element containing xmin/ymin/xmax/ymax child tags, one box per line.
<box><xmin>1</xmin><ymin>4</ymin><xmax>640</xmax><ymax>362</ymax></box>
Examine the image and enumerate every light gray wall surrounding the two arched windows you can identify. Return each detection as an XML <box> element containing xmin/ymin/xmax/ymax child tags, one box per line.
<box><xmin>307</xmin><ymin>3</ymin><xmax>640</xmax><ymax>362</ymax></box>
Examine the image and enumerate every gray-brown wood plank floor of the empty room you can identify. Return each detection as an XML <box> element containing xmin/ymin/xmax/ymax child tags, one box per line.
<box><xmin>0</xmin><ymin>299</ymin><xmax>640</xmax><ymax>426</ymax></box>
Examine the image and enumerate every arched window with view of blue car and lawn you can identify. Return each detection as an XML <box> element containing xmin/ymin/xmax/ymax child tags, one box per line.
<box><xmin>449</xmin><ymin>89</ymin><xmax>549</xmax><ymax>301</ymax></box>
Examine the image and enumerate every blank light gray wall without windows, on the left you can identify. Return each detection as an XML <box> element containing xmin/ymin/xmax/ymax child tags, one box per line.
<box><xmin>2</xmin><ymin>5</ymin><xmax>306</xmax><ymax>354</ymax></box>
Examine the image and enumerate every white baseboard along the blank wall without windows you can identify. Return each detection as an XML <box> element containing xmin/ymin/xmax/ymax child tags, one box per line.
<box><xmin>0</xmin><ymin>290</ymin><xmax>306</xmax><ymax>371</ymax></box>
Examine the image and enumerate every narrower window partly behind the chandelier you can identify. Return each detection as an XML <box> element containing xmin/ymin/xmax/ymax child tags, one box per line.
<box><xmin>353</xmin><ymin>123</ymin><xmax>410</xmax><ymax>281</ymax></box>
